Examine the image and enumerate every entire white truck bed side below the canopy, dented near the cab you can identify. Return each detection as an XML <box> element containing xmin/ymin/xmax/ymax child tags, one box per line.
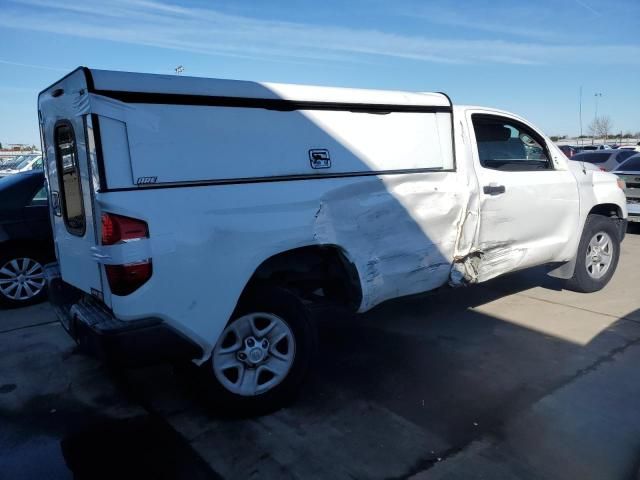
<box><xmin>104</xmin><ymin>172</ymin><xmax>469</xmax><ymax>358</ymax></box>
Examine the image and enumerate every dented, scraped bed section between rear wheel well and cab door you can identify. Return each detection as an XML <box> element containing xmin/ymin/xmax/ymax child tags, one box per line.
<box><xmin>313</xmin><ymin>172</ymin><xmax>468</xmax><ymax>311</ymax></box>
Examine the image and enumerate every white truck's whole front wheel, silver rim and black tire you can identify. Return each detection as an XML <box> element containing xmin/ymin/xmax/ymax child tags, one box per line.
<box><xmin>568</xmin><ymin>215</ymin><xmax>620</xmax><ymax>293</ymax></box>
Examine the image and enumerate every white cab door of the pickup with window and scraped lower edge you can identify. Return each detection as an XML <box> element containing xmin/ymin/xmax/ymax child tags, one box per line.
<box><xmin>468</xmin><ymin>111</ymin><xmax>579</xmax><ymax>281</ymax></box>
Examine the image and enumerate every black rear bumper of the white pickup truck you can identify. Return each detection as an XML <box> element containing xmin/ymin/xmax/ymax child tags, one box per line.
<box><xmin>45</xmin><ymin>264</ymin><xmax>203</xmax><ymax>366</ymax></box>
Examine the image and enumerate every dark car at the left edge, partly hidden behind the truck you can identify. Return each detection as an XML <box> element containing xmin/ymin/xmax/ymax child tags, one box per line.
<box><xmin>0</xmin><ymin>170</ymin><xmax>55</xmax><ymax>307</ymax></box>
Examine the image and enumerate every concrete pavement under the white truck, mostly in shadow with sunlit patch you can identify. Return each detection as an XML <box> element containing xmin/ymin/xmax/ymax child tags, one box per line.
<box><xmin>0</xmin><ymin>226</ymin><xmax>640</xmax><ymax>479</ymax></box>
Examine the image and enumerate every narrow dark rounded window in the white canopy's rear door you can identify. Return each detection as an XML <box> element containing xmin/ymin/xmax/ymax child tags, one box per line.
<box><xmin>54</xmin><ymin>123</ymin><xmax>86</xmax><ymax>237</ymax></box>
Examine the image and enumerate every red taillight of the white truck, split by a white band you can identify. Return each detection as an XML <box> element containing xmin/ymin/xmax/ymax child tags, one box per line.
<box><xmin>101</xmin><ymin>213</ymin><xmax>153</xmax><ymax>296</ymax></box>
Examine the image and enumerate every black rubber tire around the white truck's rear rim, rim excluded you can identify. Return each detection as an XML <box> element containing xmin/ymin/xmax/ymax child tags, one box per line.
<box><xmin>198</xmin><ymin>287</ymin><xmax>317</xmax><ymax>417</ymax></box>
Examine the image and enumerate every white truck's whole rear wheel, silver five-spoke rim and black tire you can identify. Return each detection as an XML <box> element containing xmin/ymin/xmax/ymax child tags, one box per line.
<box><xmin>200</xmin><ymin>287</ymin><xmax>317</xmax><ymax>416</ymax></box>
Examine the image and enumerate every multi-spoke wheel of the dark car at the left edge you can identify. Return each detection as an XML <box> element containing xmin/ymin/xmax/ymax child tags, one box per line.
<box><xmin>0</xmin><ymin>249</ymin><xmax>46</xmax><ymax>307</ymax></box>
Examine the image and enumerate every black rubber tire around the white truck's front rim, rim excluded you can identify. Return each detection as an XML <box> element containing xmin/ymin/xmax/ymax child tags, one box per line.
<box><xmin>567</xmin><ymin>215</ymin><xmax>620</xmax><ymax>293</ymax></box>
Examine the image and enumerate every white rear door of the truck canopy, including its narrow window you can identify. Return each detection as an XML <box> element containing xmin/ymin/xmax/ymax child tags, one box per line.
<box><xmin>43</xmin><ymin>116</ymin><xmax>103</xmax><ymax>294</ymax></box>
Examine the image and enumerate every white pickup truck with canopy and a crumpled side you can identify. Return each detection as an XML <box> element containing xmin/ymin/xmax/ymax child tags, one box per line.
<box><xmin>38</xmin><ymin>67</ymin><xmax>627</xmax><ymax>412</ymax></box>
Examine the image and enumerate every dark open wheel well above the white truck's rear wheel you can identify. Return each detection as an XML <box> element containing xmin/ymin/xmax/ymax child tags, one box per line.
<box><xmin>241</xmin><ymin>245</ymin><xmax>362</xmax><ymax>309</ymax></box>
